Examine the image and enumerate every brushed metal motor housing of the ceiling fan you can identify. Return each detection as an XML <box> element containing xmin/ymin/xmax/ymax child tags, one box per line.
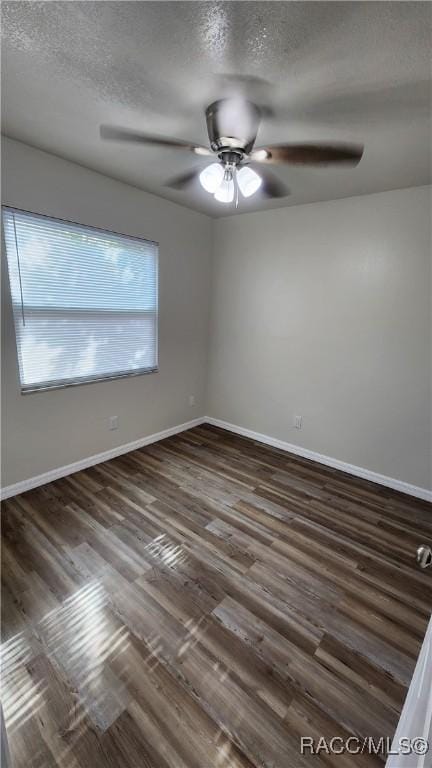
<box><xmin>206</xmin><ymin>99</ymin><xmax>261</xmax><ymax>155</ymax></box>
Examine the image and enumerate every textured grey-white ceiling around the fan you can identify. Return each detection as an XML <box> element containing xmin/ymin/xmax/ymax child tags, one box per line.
<box><xmin>2</xmin><ymin>0</ymin><xmax>432</xmax><ymax>216</ymax></box>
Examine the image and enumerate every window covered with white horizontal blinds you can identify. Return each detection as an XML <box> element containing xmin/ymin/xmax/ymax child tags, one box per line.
<box><xmin>3</xmin><ymin>208</ymin><xmax>158</xmax><ymax>392</ymax></box>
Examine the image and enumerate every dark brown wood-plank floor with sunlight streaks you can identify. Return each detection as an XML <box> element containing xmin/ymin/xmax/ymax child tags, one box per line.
<box><xmin>2</xmin><ymin>426</ymin><xmax>432</xmax><ymax>768</ymax></box>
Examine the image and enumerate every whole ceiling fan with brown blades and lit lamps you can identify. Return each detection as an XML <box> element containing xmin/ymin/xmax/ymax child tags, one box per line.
<box><xmin>100</xmin><ymin>98</ymin><xmax>363</xmax><ymax>204</ymax></box>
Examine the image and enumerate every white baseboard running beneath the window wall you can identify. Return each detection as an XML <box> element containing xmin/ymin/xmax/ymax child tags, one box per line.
<box><xmin>0</xmin><ymin>417</ymin><xmax>206</xmax><ymax>499</ymax></box>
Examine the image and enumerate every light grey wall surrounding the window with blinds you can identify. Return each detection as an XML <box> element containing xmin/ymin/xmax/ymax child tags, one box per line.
<box><xmin>2</xmin><ymin>140</ymin><xmax>211</xmax><ymax>486</ymax></box>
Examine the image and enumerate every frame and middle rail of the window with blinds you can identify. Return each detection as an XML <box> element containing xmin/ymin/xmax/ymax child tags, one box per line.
<box><xmin>1</xmin><ymin>203</ymin><xmax>159</xmax><ymax>395</ymax></box>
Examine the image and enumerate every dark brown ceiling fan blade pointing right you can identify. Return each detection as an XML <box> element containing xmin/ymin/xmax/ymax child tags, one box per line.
<box><xmin>251</xmin><ymin>144</ymin><xmax>363</xmax><ymax>165</ymax></box>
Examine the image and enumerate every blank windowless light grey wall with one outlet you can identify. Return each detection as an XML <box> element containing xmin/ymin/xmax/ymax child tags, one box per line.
<box><xmin>207</xmin><ymin>187</ymin><xmax>432</xmax><ymax>488</ymax></box>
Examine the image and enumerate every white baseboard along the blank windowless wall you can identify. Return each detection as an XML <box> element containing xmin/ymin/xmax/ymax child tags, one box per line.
<box><xmin>204</xmin><ymin>416</ymin><xmax>432</xmax><ymax>502</ymax></box>
